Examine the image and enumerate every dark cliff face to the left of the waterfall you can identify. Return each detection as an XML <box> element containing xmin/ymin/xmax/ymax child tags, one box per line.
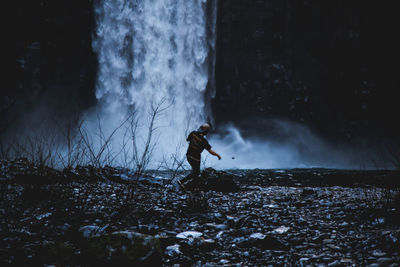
<box><xmin>7</xmin><ymin>0</ymin><xmax>97</xmax><ymax>134</ymax></box>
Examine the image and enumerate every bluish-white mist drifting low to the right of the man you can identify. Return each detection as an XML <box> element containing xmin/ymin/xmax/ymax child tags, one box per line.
<box><xmin>203</xmin><ymin>120</ymin><xmax>377</xmax><ymax>169</ymax></box>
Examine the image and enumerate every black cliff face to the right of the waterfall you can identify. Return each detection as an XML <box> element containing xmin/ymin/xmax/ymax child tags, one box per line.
<box><xmin>213</xmin><ymin>0</ymin><xmax>400</xmax><ymax>144</ymax></box>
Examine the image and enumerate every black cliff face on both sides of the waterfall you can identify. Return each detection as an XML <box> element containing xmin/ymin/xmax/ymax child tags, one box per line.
<box><xmin>9</xmin><ymin>0</ymin><xmax>400</xmax><ymax>147</ymax></box>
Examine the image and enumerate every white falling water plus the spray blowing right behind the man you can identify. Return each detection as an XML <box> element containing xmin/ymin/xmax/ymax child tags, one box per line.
<box><xmin>89</xmin><ymin>0</ymin><xmax>380</xmax><ymax>169</ymax></box>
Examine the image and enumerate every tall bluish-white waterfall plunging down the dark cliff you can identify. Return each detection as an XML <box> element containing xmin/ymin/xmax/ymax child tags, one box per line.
<box><xmin>93</xmin><ymin>0</ymin><xmax>217</xmax><ymax>168</ymax></box>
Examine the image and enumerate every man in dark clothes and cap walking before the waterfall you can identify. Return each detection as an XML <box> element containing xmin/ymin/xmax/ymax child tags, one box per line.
<box><xmin>178</xmin><ymin>123</ymin><xmax>221</xmax><ymax>191</ymax></box>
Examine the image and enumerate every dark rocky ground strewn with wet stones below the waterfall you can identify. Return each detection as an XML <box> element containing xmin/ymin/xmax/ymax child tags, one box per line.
<box><xmin>0</xmin><ymin>160</ymin><xmax>400</xmax><ymax>266</ymax></box>
